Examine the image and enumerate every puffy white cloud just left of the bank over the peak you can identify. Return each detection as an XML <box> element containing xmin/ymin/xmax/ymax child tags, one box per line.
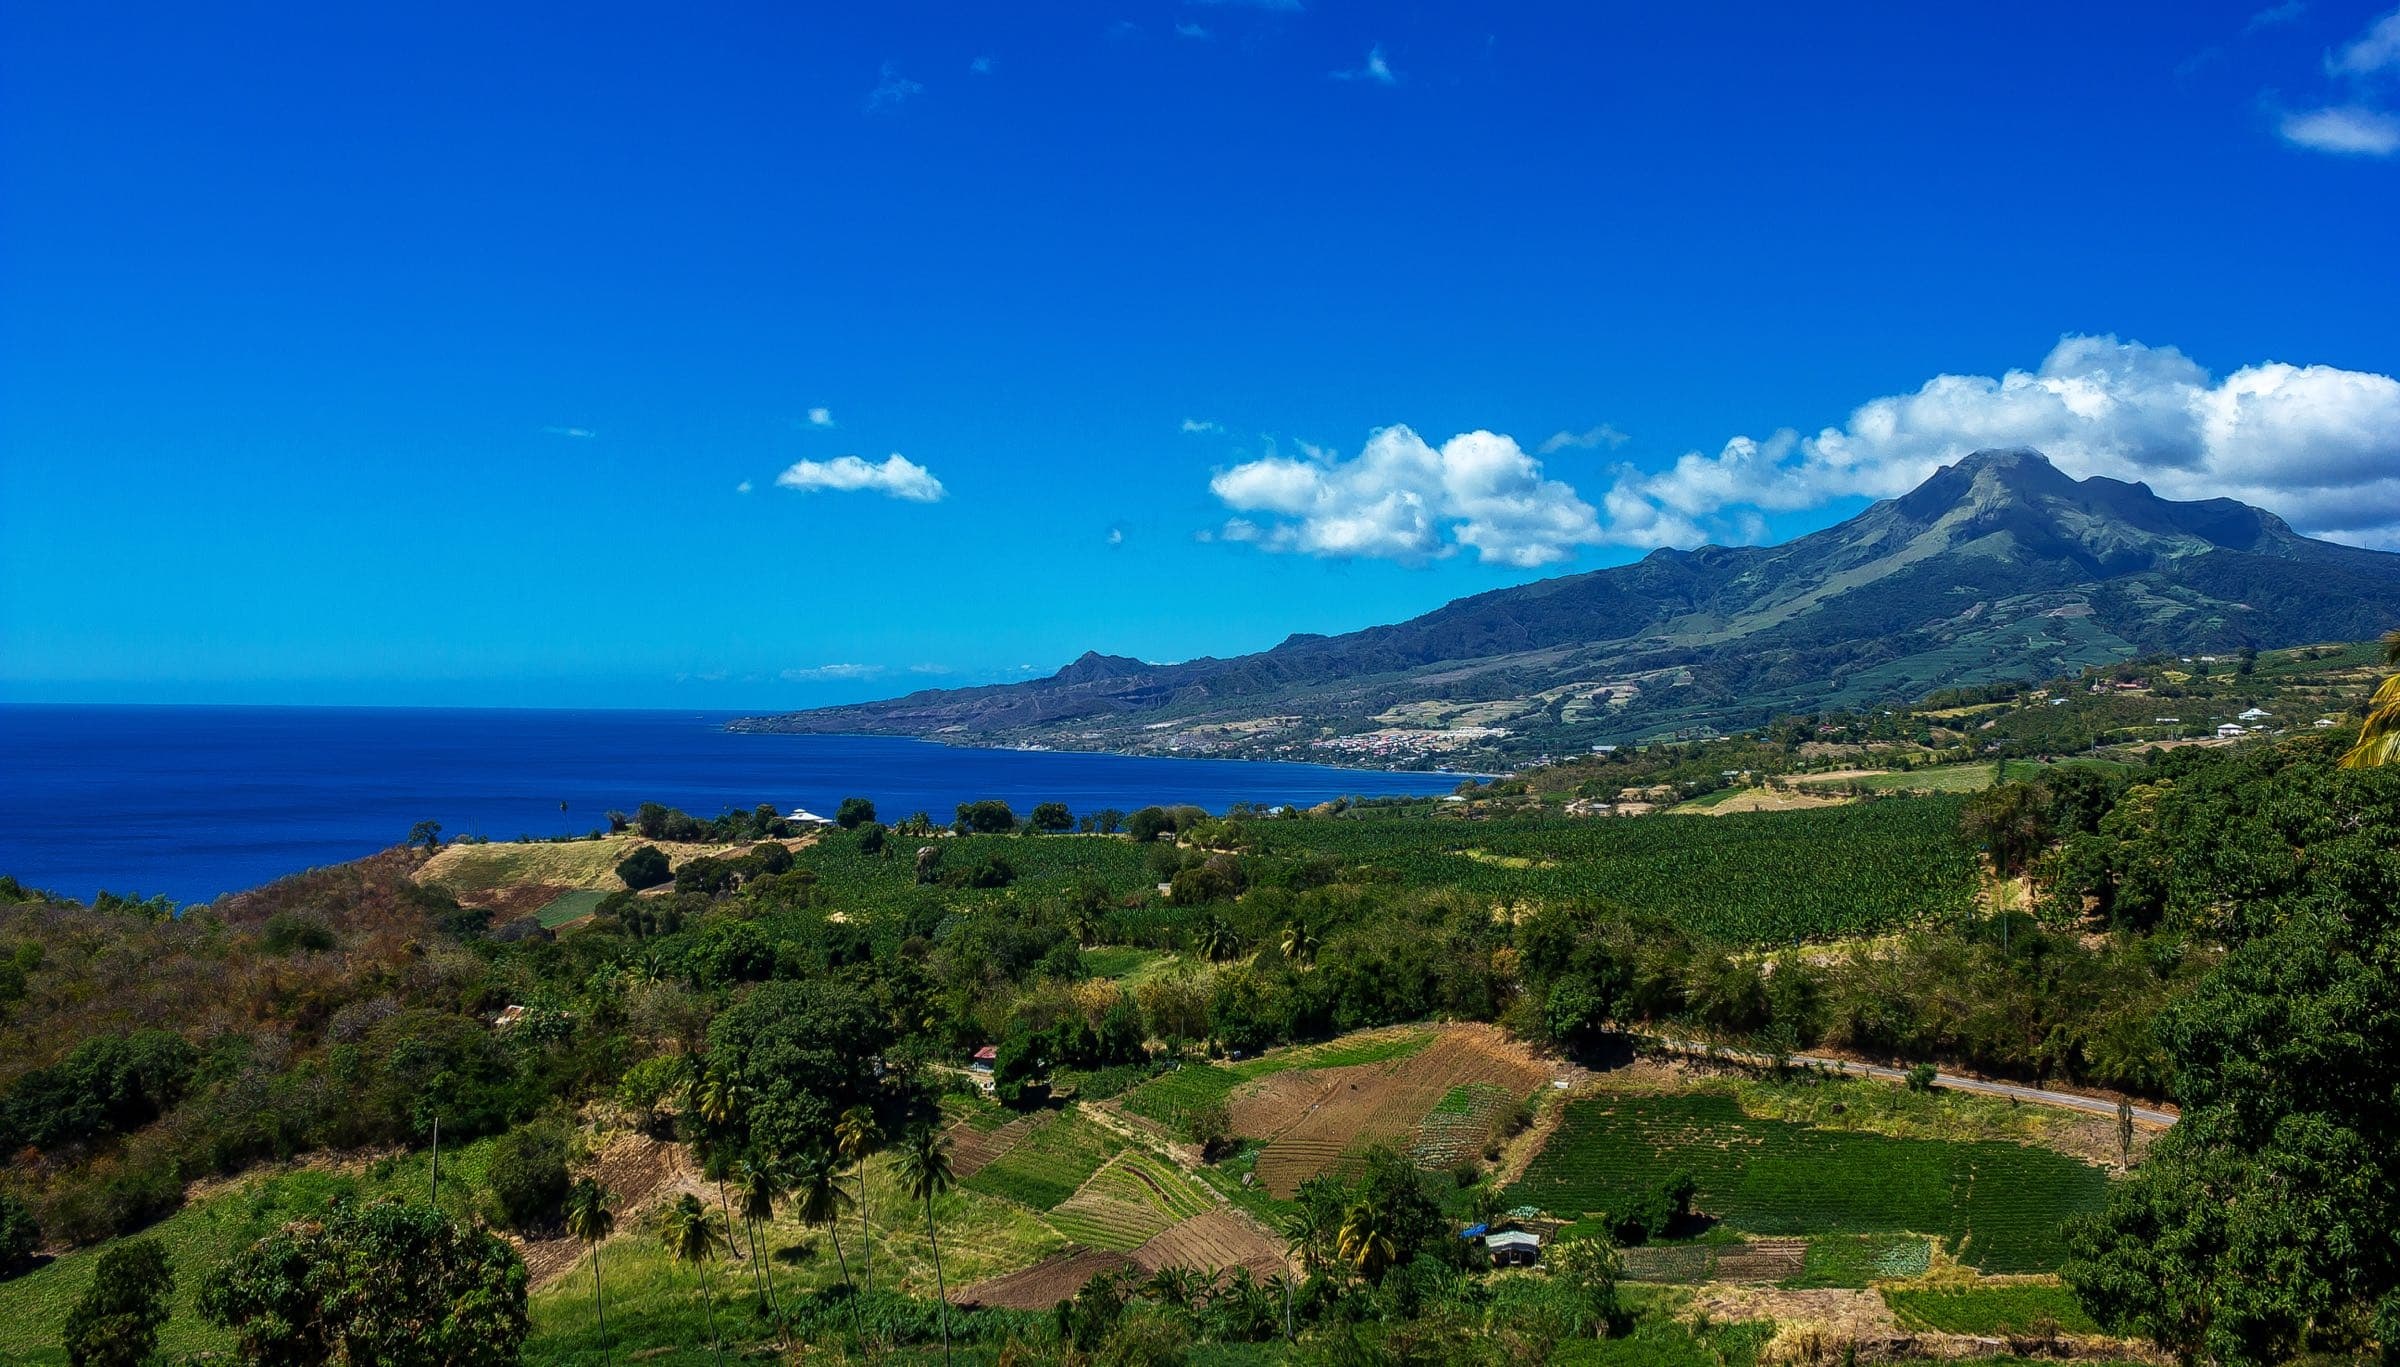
<box><xmin>1210</xmin><ymin>424</ymin><xmax>1601</xmax><ymax>558</ymax></box>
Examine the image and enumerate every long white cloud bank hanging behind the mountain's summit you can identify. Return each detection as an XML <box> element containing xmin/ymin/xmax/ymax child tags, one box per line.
<box><xmin>1603</xmin><ymin>336</ymin><xmax>2400</xmax><ymax>547</ymax></box>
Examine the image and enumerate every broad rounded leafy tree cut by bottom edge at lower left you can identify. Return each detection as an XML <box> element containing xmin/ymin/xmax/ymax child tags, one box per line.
<box><xmin>199</xmin><ymin>1199</ymin><xmax>528</xmax><ymax>1367</ymax></box>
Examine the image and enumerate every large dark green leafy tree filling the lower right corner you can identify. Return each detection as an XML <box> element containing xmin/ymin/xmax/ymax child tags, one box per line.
<box><xmin>2062</xmin><ymin>844</ymin><xmax>2400</xmax><ymax>1365</ymax></box>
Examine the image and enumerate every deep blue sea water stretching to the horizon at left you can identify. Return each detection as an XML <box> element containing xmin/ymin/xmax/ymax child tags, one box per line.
<box><xmin>0</xmin><ymin>705</ymin><xmax>1459</xmax><ymax>902</ymax></box>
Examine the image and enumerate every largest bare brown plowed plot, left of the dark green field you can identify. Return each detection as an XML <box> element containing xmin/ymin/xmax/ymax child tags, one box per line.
<box><xmin>1226</xmin><ymin>1024</ymin><xmax>1567</xmax><ymax>1199</ymax></box>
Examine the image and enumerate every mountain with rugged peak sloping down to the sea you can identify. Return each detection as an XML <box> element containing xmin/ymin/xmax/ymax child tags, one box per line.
<box><xmin>734</xmin><ymin>451</ymin><xmax>2400</xmax><ymax>763</ymax></box>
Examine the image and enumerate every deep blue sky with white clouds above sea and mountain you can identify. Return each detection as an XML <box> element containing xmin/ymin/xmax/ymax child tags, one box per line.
<box><xmin>0</xmin><ymin>0</ymin><xmax>2400</xmax><ymax>707</ymax></box>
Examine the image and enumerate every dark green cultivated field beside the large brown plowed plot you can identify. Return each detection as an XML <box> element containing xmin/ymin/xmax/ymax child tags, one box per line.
<box><xmin>1505</xmin><ymin>1094</ymin><xmax>2107</xmax><ymax>1271</ymax></box>
